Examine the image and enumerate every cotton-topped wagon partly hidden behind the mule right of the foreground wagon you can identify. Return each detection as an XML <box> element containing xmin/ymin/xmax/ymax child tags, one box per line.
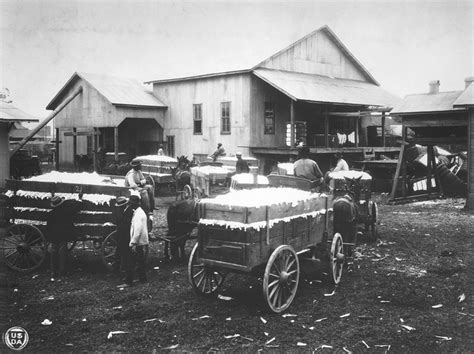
<box><xmin>328</xmin><ymin>171</ymin><xmax>378</xmax><ymax>241</ymax></box>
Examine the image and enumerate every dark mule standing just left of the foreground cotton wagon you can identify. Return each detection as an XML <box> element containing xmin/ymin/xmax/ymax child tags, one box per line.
<box><xmin>164</xmin><ymin>199</ymin><xmax>199</xmax><ymax>261</ymax></box>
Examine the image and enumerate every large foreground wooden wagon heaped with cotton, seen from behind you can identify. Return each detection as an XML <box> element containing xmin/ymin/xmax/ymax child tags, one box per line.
<box><xmin>188</xmin><ymin>175</ymin><xmax>344</xmax><ymax>313</ymax></box>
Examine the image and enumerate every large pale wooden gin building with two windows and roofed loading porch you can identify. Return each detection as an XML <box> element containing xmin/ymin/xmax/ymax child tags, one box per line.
<box><xmin>147</xmin><ymin>26</ymin><xmax>400</xmax><ymax>171</ymax></box>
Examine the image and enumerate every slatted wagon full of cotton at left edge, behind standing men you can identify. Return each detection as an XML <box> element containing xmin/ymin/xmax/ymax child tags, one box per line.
<box><xmin>0</xmin><ymin>173</ymin><xmax>135</xmax><ymax>272</ymax></box>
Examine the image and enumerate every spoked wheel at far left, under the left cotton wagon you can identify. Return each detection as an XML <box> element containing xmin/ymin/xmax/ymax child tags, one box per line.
<box><xmin>0</xmin><ymin>224</ymin><xmax>47</xmax><ymax>272</ymax></box>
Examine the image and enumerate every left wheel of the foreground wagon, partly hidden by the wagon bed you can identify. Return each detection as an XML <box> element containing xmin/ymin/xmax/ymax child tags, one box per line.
<box><xmin>188</xmin><ymin>243</ymin><xmax>225</xmax><ymax>296</ymax></box>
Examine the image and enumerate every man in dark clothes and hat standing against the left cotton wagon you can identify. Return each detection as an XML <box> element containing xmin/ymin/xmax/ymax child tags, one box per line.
<box><xmin>46</xmin><ymin>195</ymin><xmax>82</xmax><ymax>279</ymax></box>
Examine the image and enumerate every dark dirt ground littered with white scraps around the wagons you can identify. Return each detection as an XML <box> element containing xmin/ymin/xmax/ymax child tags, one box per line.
<box><xmin>1</xmin><ymin>195</ymin><xmax>474</xmax><ymax>353</ymax></box>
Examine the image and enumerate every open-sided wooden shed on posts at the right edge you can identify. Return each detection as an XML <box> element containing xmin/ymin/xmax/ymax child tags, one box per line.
<box><xmin>391</xmin><ymin>77</ymin><xmax>474</xmax><ymax>209</ymax></box>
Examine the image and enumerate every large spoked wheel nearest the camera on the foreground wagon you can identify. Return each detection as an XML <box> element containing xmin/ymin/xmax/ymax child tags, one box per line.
<box><xmin>263</xmin><ymin>245</ymin><xmax>300</xmax><ymax>313</ymax></box>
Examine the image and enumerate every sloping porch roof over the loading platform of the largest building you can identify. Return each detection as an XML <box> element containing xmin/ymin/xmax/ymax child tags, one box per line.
<box><xmin>253</xmin><ymin>69</ymin><xmax>400</xmax><ymax>107</ymax></box>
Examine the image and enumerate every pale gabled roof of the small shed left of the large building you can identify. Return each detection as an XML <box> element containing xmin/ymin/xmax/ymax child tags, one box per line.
<box><xmin>46</xmin><ymin>72</ymin><xmax>166</xmax><ymax>110</ymax></box>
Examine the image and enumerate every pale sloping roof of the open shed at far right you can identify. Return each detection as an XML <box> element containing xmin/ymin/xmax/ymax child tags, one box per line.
<box><xmin>391</xmin><ymin>91</ymin><xmax>462</xmax><ymax>115</ymax></box>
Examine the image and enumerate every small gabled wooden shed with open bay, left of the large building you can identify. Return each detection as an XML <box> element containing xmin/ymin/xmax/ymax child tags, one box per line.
<box><xmin>46</xmin><ymin>73</ymin><xmax>167</xmax><ymax>170</ymax></box>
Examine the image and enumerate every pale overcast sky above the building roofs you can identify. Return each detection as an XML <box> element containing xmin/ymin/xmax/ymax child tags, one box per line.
<box><xmin>0</xmin><ymin>0</ymin><xmax>474</xmax><ymax>118</ymax></box>
